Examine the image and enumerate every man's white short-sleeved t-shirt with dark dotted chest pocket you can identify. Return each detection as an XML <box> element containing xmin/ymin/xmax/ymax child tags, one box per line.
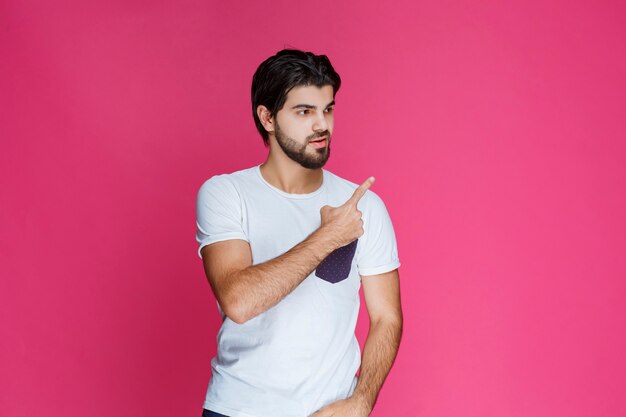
<box><xmin>196</xmin><ymin>165</ymin><xmax>400</xmax><ymax>417</ymax></box>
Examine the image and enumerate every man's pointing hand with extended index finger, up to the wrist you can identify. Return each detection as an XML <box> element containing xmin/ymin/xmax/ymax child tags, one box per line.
<box><xmin>320</xmin><ymin>177</ymin><xmax>374</xmax><ymax>248</ymax></box>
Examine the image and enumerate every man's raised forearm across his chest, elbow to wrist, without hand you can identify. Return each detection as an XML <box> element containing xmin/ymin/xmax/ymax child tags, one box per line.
<box><xmin>227</xmin><ymin>229</ymin><xmax>336</xmax><ymax>323</ymax></box>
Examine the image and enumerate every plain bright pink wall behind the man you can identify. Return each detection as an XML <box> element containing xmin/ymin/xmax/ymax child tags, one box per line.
<box><xmin>0</xmin><ymin>0</ymin><xmax>626</xmax><ymax>417</ymax></box>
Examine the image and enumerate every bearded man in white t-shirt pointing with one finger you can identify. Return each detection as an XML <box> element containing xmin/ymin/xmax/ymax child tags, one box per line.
<box><xmin>196</xmin><ymin>50</ymin><xmax>402</xmax><ymax>417</ymax></box>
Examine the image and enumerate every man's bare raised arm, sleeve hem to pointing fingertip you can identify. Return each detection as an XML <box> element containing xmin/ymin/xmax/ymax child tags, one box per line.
<box><xmin>201</xmin><ymin>177</ymin><xmax>374</xmax><ymax>324</ymax></box>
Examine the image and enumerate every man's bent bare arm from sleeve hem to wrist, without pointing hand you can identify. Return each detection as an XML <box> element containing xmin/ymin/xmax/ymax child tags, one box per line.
<box><xmin>201</xmin><ymin>228</ymin><xmax>336</xmax><ymax>324</ymax></box>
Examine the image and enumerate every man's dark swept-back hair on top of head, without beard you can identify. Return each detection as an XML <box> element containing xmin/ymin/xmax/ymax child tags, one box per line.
<box><xmin>252</xmin><ymin>49</ymin><xmax>341</xmax><ymax>146</ymax></box>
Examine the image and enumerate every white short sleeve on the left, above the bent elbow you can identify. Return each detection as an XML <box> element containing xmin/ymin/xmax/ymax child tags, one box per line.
<box><xmin>196</xmin><ymin>174</ymin><xmax>249</xmax><ymax>258</ymax></box>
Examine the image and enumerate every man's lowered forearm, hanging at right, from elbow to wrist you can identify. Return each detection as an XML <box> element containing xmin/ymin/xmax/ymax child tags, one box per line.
<box><xmin>352</xmin><ymin>316</ymin><xmax>402</xmax><ymax>413</ymax></box>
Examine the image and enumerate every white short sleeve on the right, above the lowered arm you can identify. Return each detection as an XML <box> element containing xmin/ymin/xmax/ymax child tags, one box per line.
<box><xmin>357</xmin><ymin>190</ymin><xmax>400</xmax><ymax>275</ymax></box>
